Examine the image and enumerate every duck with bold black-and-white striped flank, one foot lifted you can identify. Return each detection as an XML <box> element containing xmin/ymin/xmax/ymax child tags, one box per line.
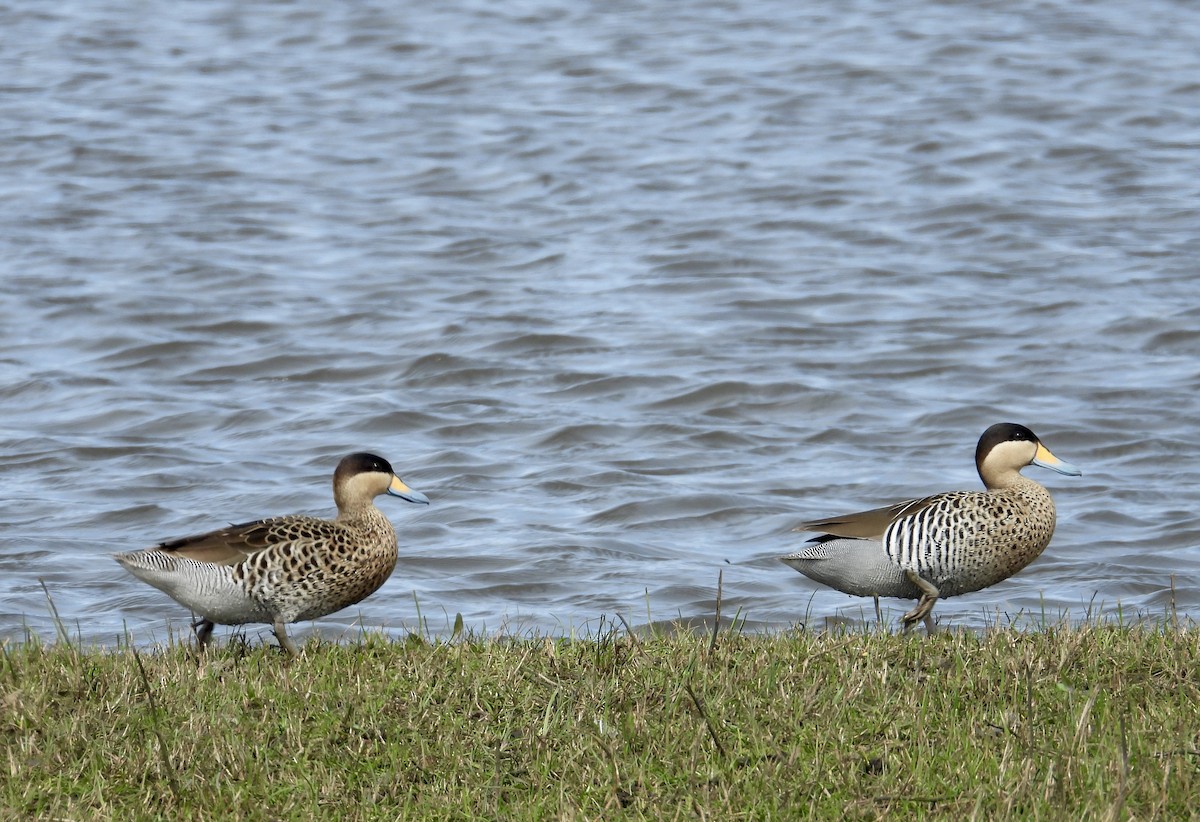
<box><xmin>780</xmin><ymin>422</ymin><xmax>1080</xmax><ymax>631</ymax></box>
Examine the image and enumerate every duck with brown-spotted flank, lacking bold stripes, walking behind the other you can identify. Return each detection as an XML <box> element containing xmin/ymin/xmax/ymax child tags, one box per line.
<box><xmin>114</xmin><ymin>454</ymin><xmax>430</xmax><ymax>656</ymax></box>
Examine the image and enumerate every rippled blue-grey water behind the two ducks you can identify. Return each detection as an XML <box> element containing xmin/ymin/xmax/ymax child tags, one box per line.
<box><xmin>0</xmin><ymin>0</ymin><xmax>1200</xmax><ymax>643</ymax></box>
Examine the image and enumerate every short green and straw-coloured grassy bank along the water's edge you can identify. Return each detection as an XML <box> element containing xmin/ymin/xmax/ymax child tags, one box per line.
<box><xmin>0</xmin><ymin>625</ymin><xmax>1200</xmax><ymax>820</ymax></box>
